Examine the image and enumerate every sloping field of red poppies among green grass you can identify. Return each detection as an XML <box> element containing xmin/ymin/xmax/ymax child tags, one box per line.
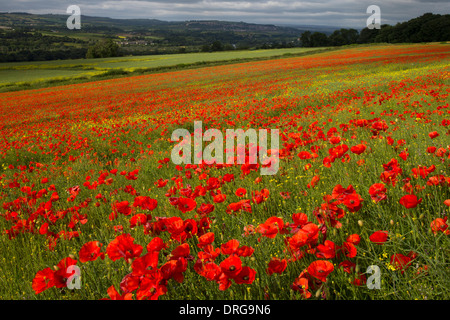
<box><xmin>0</xmin><ymin>43</ymin><xmax>450</xmax><ymax>300</ymax></box>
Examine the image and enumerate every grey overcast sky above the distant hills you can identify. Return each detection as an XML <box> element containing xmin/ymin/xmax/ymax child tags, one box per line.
<box><xmin>0</xmin><ymin>0</ymin><xmax>450</xmax><ymax>29</ymax></box>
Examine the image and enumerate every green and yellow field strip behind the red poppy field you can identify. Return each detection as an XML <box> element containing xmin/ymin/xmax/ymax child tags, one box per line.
<box><xmin>0</xmin><ymin>48</ymin><xmax>330</xmax><ymax>92</ymax></box>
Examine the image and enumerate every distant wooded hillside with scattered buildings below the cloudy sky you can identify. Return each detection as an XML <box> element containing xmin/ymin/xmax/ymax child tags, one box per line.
<box><xmin>0</xmin><ymin>13</ymin><xmax>330</xmax><ymax>62</ymax></box>
